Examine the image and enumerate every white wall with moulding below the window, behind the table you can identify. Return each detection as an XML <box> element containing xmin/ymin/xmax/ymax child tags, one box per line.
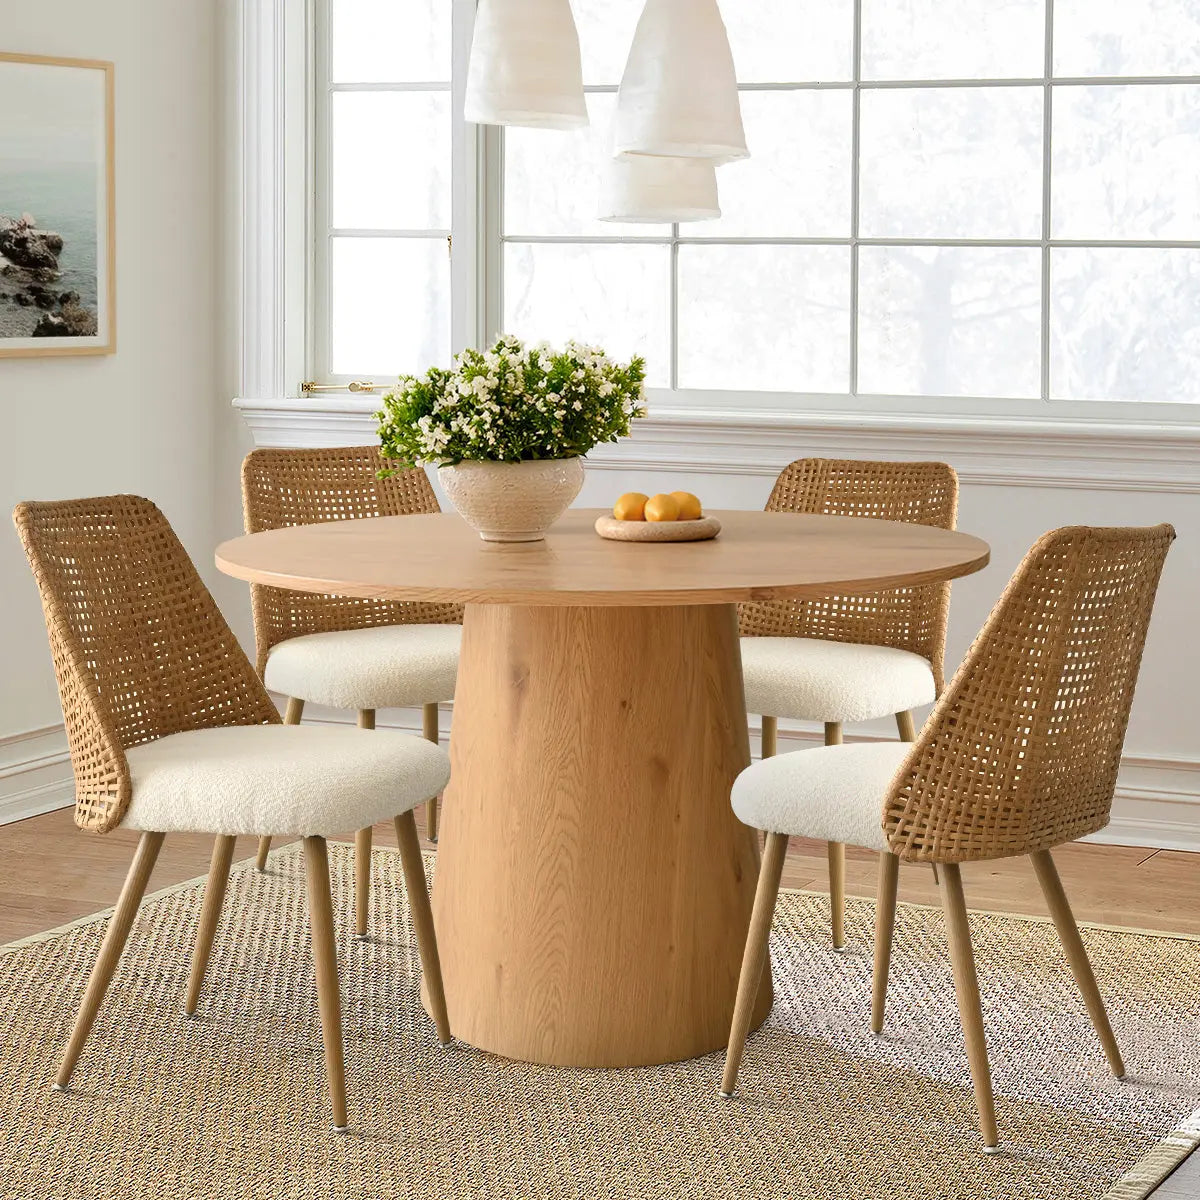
<box><xmin>231</xmin><ymin>397</ymin><xmax>1200</xmax><ymax>850</ymax></box>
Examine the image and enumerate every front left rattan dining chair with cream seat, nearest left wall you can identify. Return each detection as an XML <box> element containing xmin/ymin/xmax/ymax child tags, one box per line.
<box><xmin>13</xmin><ymin>496</ymin><xmax>450</xmax><ymax>1132</ymax></box>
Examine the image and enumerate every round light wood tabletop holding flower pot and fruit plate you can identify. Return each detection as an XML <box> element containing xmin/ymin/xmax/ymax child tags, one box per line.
<box><xmin>217</xmin><ymin>509</ymin><xmax>988</xmax><ymax>607</ymax></box>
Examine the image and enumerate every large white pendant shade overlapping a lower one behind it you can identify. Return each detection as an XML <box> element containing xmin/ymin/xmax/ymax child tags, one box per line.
<box><xmin>613</xmin><ymin>0</ymin><xmax>749</xmax><ymax>162</ymax></box>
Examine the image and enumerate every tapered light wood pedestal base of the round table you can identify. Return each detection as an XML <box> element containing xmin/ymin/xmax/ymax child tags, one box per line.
<box><xmin>433</xmin><ymin>604</ymin><xmax>772</xmax><ymax>1067</ymax></box>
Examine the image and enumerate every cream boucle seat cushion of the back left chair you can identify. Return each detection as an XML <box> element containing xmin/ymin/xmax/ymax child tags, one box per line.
<box><xmin>264</xmin><ymin>625</ymin><xmax>462</xmax><ymax>708</ymax></box>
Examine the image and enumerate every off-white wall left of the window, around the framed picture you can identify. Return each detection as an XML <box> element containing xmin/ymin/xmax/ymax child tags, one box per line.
<box><xmin>0</xmin><ymin>0</ymin><xmax>223</xmax><ymax>820</ymax></box>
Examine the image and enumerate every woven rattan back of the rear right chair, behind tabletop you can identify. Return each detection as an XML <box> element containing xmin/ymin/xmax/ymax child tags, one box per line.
<box><xmin>739</xmin><ymin>458</ymin><xmax>959</xmax><ymax>691</ymax></box>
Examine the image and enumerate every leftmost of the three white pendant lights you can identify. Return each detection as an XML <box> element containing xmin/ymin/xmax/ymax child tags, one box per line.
<box><xmin>463</xmin><ymin>0</ymin><xmax>588</xmax><ymax>130</ymax></box>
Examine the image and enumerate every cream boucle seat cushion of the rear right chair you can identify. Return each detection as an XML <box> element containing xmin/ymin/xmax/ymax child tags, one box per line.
<box><xmin>742</xmin><ymin>637</ymin><xmax>937</xmax><ymax>721</ymax></box>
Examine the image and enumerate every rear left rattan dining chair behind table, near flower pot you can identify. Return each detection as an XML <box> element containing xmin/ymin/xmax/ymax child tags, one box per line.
<box><xmin>241</xmin><ymin>446</ymin><xmax>462</xmax><ymax>937</ymax></box>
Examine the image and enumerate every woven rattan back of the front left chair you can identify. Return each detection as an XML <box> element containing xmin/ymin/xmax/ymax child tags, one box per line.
<box><xmin>13</xmin><ymin>496</ymin><xmax>280</xmax><ymax>833</ymax></box>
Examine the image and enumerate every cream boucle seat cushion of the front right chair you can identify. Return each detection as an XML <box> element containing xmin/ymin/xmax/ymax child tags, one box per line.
<box><xmin>732</xmin><ymin>742</ymin><xmax>912</xmax><ymax>850</ymax></box>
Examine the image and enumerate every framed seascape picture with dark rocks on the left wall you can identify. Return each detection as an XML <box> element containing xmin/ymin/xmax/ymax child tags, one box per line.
<box><xmin>0</xmin><ymin>53</ymin><xmax>116</xmax><ymax>358</ymax></box>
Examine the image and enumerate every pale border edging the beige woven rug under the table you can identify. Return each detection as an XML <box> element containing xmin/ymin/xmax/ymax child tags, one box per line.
<box><xmin>0</xmin><ymin>841</ymin><xmax>1200</xmax><ymax>1200</ymax></box>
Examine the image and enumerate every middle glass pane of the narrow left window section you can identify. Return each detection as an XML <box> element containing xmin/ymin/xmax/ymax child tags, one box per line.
<box><xmin>331</xmin><ymin>91</ymin><xmax>450</xmax><ymax>229</ymax></box>
